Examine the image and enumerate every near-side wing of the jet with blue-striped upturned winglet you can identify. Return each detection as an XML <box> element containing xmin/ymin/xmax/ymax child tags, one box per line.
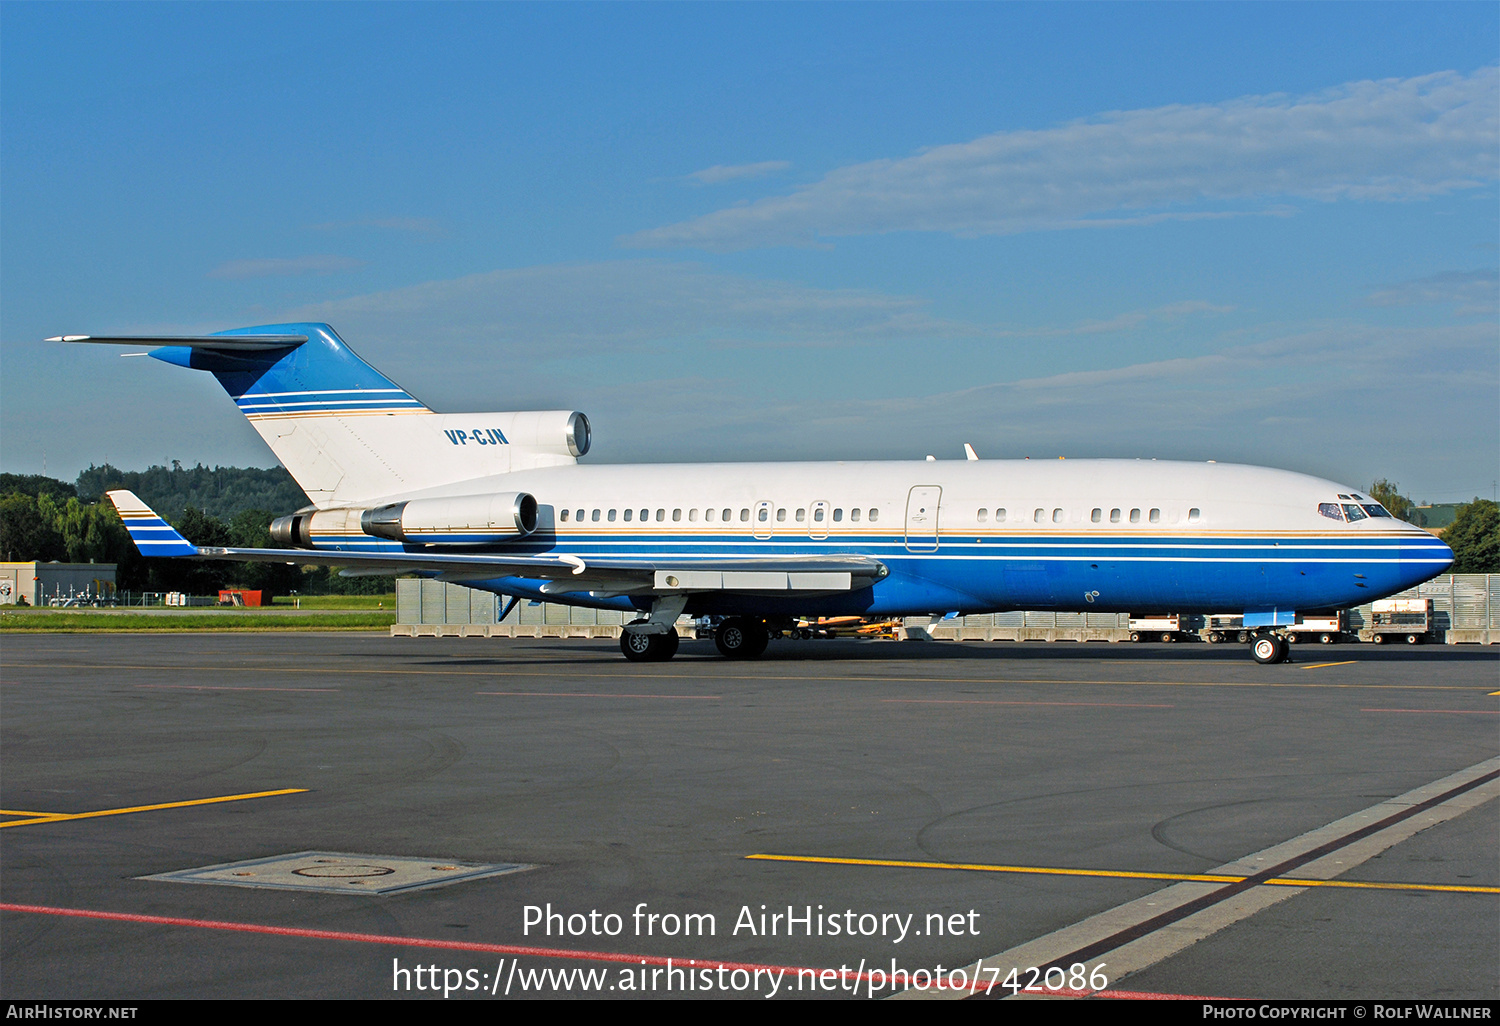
<box><xmin>107</xmin><ymin>489</ymin><xmax>887</xmax><ymax>594</ymax></box>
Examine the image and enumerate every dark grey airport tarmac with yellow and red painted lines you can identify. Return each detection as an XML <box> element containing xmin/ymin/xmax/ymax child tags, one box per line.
<box><xmin>0</xmin><ymin>633</ymin><xmax>1500</xmax><ymax>1001</ymax></box>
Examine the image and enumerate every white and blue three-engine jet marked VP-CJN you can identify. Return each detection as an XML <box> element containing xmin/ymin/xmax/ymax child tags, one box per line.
<box><xmin>61</xmin><ymin>324</ymin><xmax>1454</xmax><ymax>663</ymax></box>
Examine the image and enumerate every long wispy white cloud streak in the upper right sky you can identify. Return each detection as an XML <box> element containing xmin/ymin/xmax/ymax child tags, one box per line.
<box><xmin>623</xmin><ymin>68</ymin><xmax>1500</xmax><ymax>249</ymax></box>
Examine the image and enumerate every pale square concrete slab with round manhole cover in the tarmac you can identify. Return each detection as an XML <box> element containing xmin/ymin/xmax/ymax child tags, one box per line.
<box><xmin>138</xmin><ymin>852</ymin><xmax>534</xmax><ymax>894</ymax></box>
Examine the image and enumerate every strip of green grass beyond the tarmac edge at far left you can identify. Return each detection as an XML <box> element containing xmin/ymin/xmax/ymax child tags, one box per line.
<box><xmin>0</xmin><ymin>602</ymin><xmax>396</xmax><ymax>633</ymax></box>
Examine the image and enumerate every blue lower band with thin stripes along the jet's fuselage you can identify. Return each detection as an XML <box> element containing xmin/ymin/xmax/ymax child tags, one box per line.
<box><xmin>301</xmin><ymin>534</ymin><xmax>1452</xmax><ymax>615</ymax></box>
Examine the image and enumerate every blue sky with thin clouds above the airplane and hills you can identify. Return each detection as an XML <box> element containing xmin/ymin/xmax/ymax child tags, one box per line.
<box><xmin>0</xmin><ymin>3</ymin><xmax>1500</xmax><ymax>501</ymax></box>
